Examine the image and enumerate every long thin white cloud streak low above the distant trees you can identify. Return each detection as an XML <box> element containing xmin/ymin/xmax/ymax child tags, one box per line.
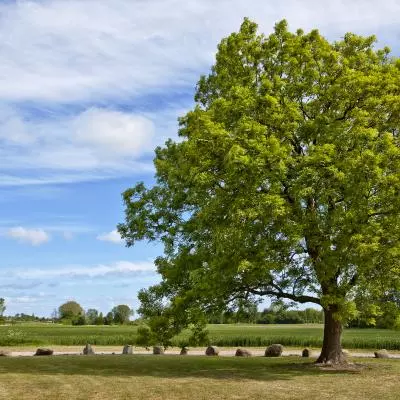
<box><xmin>15</xmin><ymin>261</ymin><xmax>156</xmax><ymax>279</ymax></box>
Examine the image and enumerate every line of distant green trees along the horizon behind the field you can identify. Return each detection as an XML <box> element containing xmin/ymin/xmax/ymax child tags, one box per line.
<box><xmin>0</xmin><ymin>292</ymin><xmax>400</xmax><ymax>329</ymax></box>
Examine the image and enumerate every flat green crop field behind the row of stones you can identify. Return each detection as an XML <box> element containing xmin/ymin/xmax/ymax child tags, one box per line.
<box><xmin>0</xmin><ymin>324</ymin><xmax>400</xmax><ymax>350</ymax></box>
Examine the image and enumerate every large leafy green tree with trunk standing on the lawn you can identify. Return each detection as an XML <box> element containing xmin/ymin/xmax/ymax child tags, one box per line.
<box><xmin>118</xmin><ymin>19</ymin><xmax>400</xmax><ymax>363</ymax></box>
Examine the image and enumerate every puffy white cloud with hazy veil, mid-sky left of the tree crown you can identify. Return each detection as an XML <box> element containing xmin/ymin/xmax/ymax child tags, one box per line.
<box><xmin>0</xmin><ymin>107</ymin><xmax>154</xmax><ymax>181</ymax></box>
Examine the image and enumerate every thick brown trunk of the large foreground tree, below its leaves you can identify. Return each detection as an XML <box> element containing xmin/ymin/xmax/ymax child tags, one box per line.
<box><xmin>317</xmin><ymin>305</ymin><xmax>346</xmax><ymax>364</ymax></box>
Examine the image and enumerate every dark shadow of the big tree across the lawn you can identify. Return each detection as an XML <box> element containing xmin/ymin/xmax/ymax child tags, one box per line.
<box><xmin>0</xmin><ymin>355</ymin><xmax>366</xmax><ymax>381</ymax></box>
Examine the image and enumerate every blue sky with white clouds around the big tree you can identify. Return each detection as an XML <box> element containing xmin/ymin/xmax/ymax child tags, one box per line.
<box><xmin>0</xmin><ymin>0</ymin><xmax>400</xmax><ymax>316</ymax></box>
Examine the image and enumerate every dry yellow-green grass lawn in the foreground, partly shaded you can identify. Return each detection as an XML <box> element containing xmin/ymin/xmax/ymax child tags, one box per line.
<box><xmin>0</xmin><ymin>355</ymin><xmax>400</xmax><ymax>400</ymax></box>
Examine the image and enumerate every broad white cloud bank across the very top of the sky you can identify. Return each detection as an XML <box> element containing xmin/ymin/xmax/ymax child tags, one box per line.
<box><xmin>0</xmin><ymin>0</ymin><xmax>400</xmax><ymax>102</ymax></box>
